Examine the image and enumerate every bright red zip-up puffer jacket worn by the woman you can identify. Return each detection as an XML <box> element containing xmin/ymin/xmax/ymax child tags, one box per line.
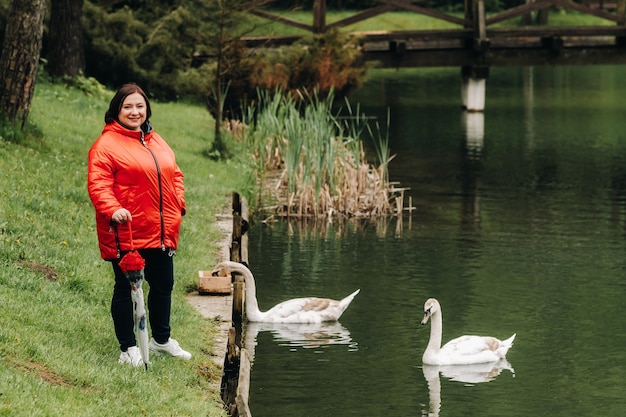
<box><xmin>87</xmin><ymin>118</ymin><xmax>185</xmax><ymax>260</ymax></box>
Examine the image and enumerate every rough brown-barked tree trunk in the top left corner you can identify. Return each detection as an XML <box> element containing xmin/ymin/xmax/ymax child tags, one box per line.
<box><xmin>0</xmin><ymin>0</ymin><xmax>47</xmax><ymax>128</ymax></box>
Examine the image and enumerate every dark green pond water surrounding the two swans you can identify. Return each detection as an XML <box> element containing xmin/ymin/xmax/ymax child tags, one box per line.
<box><xmin>245</xmin><ymin>66</ymin><xmax>626</xmax><ymax>417</ymax></box>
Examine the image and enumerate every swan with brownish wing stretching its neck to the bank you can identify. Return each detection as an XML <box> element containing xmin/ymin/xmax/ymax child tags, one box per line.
<box><xmin>212</xmin><ymin>261</ymin><xmax>360</xmax><ymax>323</ymax></box>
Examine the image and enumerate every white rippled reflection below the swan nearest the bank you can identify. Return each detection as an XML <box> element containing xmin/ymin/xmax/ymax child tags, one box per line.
<box><xmin>244</xmin><ymin>321</ymin><xmax>358</xmax><ymax>352</ymax></box>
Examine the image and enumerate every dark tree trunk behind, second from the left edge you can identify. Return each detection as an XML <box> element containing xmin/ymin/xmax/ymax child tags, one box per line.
<box><xmin>47</xmin><ymin>0</ymin><xmax>85</xmax><ymax>77</ymax></box>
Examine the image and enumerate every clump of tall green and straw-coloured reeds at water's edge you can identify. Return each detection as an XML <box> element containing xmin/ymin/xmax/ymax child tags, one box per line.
<box><xmin>231</xmin><ymin>92</ymin><xmax>404</xmax><ymax>218</ymax></box>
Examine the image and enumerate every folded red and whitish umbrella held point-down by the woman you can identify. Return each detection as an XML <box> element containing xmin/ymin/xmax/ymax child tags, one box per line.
<box><xmin>119</xmin><ymin>226</ymin><xmax>150</xmax><ymax>370</ymax></box>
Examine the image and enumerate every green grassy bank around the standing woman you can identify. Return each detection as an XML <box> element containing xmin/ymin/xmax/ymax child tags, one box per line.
<box><xmin>0</xmin><ymin>82</ymin><xmax>250</xmax><ymax>416</ymax></box>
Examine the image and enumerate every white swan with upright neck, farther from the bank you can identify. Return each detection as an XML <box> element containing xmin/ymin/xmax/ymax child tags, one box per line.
<box><xmin>422</xmin><ymin>298</ymin><xmax>515</xmax><ymax>365</ymax></box>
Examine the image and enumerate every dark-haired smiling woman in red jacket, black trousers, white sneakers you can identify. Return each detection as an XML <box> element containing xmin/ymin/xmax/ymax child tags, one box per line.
<box><xmin>87</xmin><ymin>83</ymin><xmax>191</xmax><ymax>366</ymax></box>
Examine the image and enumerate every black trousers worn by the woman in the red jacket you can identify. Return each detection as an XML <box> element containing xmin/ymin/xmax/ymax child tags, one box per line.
<box><xmin>111</xmin><ymin>249</ymin><xmax>174</xmax><ymax>351</ymax></box>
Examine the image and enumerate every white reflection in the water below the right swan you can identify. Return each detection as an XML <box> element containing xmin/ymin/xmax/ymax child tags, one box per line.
<box><xmin>422</xmin><ymin>359</ymin><xmax>515</xmax><ymax>417</ymax></box>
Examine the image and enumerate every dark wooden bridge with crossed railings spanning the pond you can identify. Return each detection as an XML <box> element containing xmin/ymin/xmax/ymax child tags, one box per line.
<box><xmin>243</xmin><ymin>0</ymin><xmax>626</xmax><ymax>111</ymax></box>
